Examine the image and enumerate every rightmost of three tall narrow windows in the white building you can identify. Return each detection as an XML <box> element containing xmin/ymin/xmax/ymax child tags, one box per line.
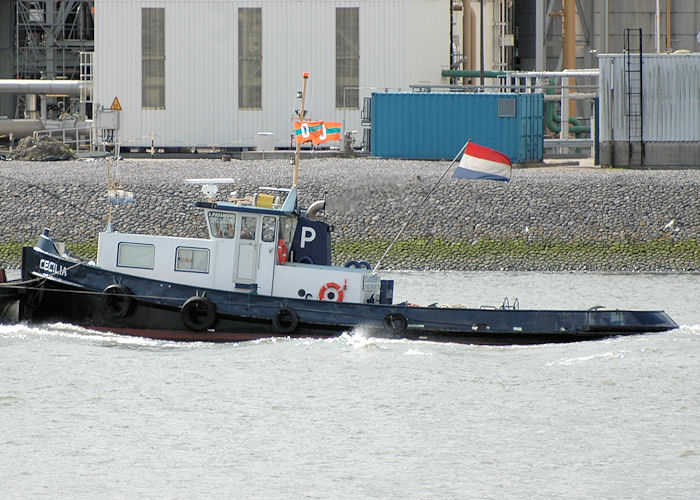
<box><xmin>335</xmin><ymin>7</ymin><xmax>360</xmax><ymax>109</ymax></box>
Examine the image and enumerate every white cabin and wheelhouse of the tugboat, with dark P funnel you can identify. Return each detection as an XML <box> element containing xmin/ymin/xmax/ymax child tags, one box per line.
<box><xmin>97</xmin><ymin>184</ymin><xmax>380</xmax><ymax>303</ymax></box>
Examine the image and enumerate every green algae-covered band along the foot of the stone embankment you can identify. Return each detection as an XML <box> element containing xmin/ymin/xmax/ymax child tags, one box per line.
<box><xmin>0</xmin><ymin>238</ymin><xmax>700</xmax><ymax>271</ymax></box>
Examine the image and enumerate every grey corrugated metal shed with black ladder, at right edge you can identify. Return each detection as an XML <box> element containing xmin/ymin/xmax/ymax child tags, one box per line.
<box><xmin>599</xmin><ymin>52</ymin><xmax>700</xmax><ymax>167</ymax></box>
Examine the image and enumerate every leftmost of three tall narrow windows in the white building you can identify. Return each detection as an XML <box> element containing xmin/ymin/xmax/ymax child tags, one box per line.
<box><xmin>141</xmin><ymin>7</ymin><xmax>165</xmax><ymax>109</ymax></box>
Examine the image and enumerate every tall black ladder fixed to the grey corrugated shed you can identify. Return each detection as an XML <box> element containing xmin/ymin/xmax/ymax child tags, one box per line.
<box><xmin>624</xmin><ymin>28</ymin><xmax>645</xmax><ymax>165</ymax></box>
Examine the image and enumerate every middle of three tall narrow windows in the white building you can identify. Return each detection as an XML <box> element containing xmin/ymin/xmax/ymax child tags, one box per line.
<box><xmin>238</xmin><ymin>7</ymin><xmax>262</xmax><ymax>109</ymax></box>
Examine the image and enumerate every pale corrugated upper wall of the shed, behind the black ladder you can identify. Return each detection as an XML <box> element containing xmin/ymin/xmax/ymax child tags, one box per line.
<box><xmin>599</xmin><ymin>53</ymin><xmax>700</xmax><ymax>142</ymax></box>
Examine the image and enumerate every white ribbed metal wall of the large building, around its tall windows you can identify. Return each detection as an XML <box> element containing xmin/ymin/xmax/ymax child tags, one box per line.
<box><xmin>94</xmin><ymin>0</ymin><xmax>450</xmax><ymax>147</ymax></box>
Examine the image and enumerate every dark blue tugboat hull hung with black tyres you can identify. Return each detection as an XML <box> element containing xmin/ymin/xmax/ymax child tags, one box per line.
<box><xmin>8</xmin><ymin>247</ymin><xmax>678</xmax><ymax>345</ymax></box>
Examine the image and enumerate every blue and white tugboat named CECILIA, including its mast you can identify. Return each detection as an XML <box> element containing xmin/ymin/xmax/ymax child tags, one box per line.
<box><xmin>0</xmin><ymin>74</ymin><xmax>678</xmax><ymax>345</ymax></box>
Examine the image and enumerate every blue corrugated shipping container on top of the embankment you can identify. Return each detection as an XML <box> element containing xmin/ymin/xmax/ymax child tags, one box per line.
<box><xmin>370</xmin><ymin>92</ymin><xmax>544</xmax><ymax>163</ymax></box>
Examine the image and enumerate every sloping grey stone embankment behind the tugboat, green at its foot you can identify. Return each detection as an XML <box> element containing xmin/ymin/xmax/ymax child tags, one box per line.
<box><xmin>0</xmin><ymin>158</ymin><xmax>700</xmax><ymax>272</ymax></box>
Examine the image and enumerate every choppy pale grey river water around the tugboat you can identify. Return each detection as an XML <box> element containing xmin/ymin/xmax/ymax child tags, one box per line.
<box><xmin>0</xmin><ymin>272</ymin><xmax>700</xmax><ymax>499</ymax></box>
